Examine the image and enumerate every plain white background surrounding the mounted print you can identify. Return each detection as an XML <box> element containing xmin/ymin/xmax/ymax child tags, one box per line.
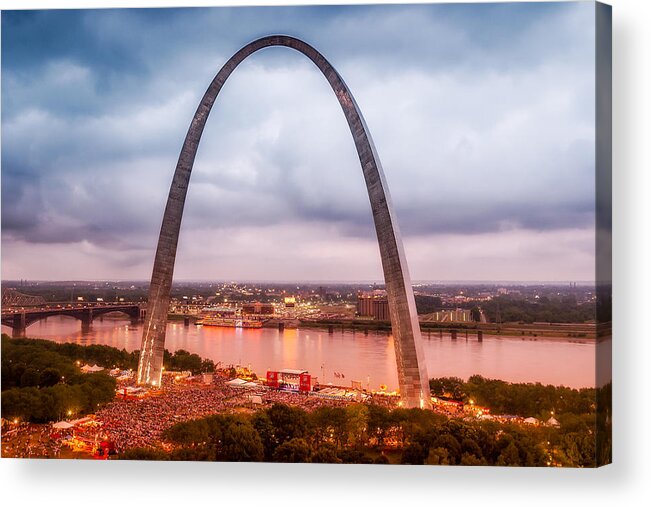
<box><xmin>0</xmin><ymin>0</ymin><xmax>651</xmax><ymax>507</ymax></box>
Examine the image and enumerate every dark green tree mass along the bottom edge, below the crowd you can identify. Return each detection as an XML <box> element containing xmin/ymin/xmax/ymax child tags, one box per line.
<box><xmin>119</xmin><ymin>404</ymin><xmax>595</xmax><ymax>466</ymax></box>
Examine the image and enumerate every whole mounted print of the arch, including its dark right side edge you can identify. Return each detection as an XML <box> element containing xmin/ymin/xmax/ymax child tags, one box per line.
<box><xmin>2</xmin><ymin>2</ymin><xmax>611</xmax><ymax>467</ymax></box>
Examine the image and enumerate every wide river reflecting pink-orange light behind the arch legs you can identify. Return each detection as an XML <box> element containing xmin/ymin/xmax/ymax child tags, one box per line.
<box><xmin>2</xmin><ymin>317</ymin><xmax>595</xmax><ymax>389</ymax></box>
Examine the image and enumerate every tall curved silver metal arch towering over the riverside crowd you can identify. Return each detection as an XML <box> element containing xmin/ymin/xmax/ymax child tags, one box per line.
<box><xmin>138</xmin><ymin>35</ymin><xmax>431</xmax><ymax>408</ymax></box>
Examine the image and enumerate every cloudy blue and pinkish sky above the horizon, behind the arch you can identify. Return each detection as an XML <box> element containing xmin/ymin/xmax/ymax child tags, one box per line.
<box><xmin>2</xmin><ymin>2</ymin><xmax>595</xmax><ymax>281</ymax></box>
